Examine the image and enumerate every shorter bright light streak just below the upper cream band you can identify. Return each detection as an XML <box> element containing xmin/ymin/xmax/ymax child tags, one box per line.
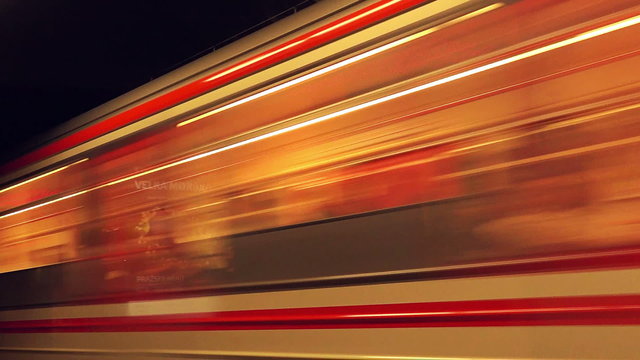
<box><xmin>176</xmin><ymin>3</ymin><xmax>503</xmax><ymax>127</ymax></box>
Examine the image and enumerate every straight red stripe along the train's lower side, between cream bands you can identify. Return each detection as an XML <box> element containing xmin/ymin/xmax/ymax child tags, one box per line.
<box><xmin>0</xmin><ymin>295</ymin><xmax>640</xmax><ymax>333</ymax></box>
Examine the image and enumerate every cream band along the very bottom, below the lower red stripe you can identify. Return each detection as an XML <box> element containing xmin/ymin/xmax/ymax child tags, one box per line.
<box><xmin>0</xmin><ymin>326</ymin><xmax>640</xmax><ymax>360</ymax></box>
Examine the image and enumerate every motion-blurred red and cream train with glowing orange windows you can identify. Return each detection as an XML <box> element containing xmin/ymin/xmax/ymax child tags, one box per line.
<box><xmin>0</xmin><ymin>0</ymin><xmax>640</xmax><ymax>360</ymax></box>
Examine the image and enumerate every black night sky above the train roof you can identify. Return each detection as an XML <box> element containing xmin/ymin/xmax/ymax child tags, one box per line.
<box><xmin>0</xmin><ymin>0</ymin><xmax>315</xmax><ymax>163</ymax></box>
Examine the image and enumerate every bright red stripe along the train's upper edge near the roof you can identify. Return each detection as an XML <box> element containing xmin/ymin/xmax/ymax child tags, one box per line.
<box><xmin>0</xmin><ymin>0</ymin><xmax>426</xmax><ymax>172</ymax></box>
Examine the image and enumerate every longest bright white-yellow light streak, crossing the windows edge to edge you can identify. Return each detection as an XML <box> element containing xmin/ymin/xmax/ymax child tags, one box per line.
<box><xmin>0</xmin><ymin>15</ymin><xmax>640</xmax><ymax>219</ymax></box>
